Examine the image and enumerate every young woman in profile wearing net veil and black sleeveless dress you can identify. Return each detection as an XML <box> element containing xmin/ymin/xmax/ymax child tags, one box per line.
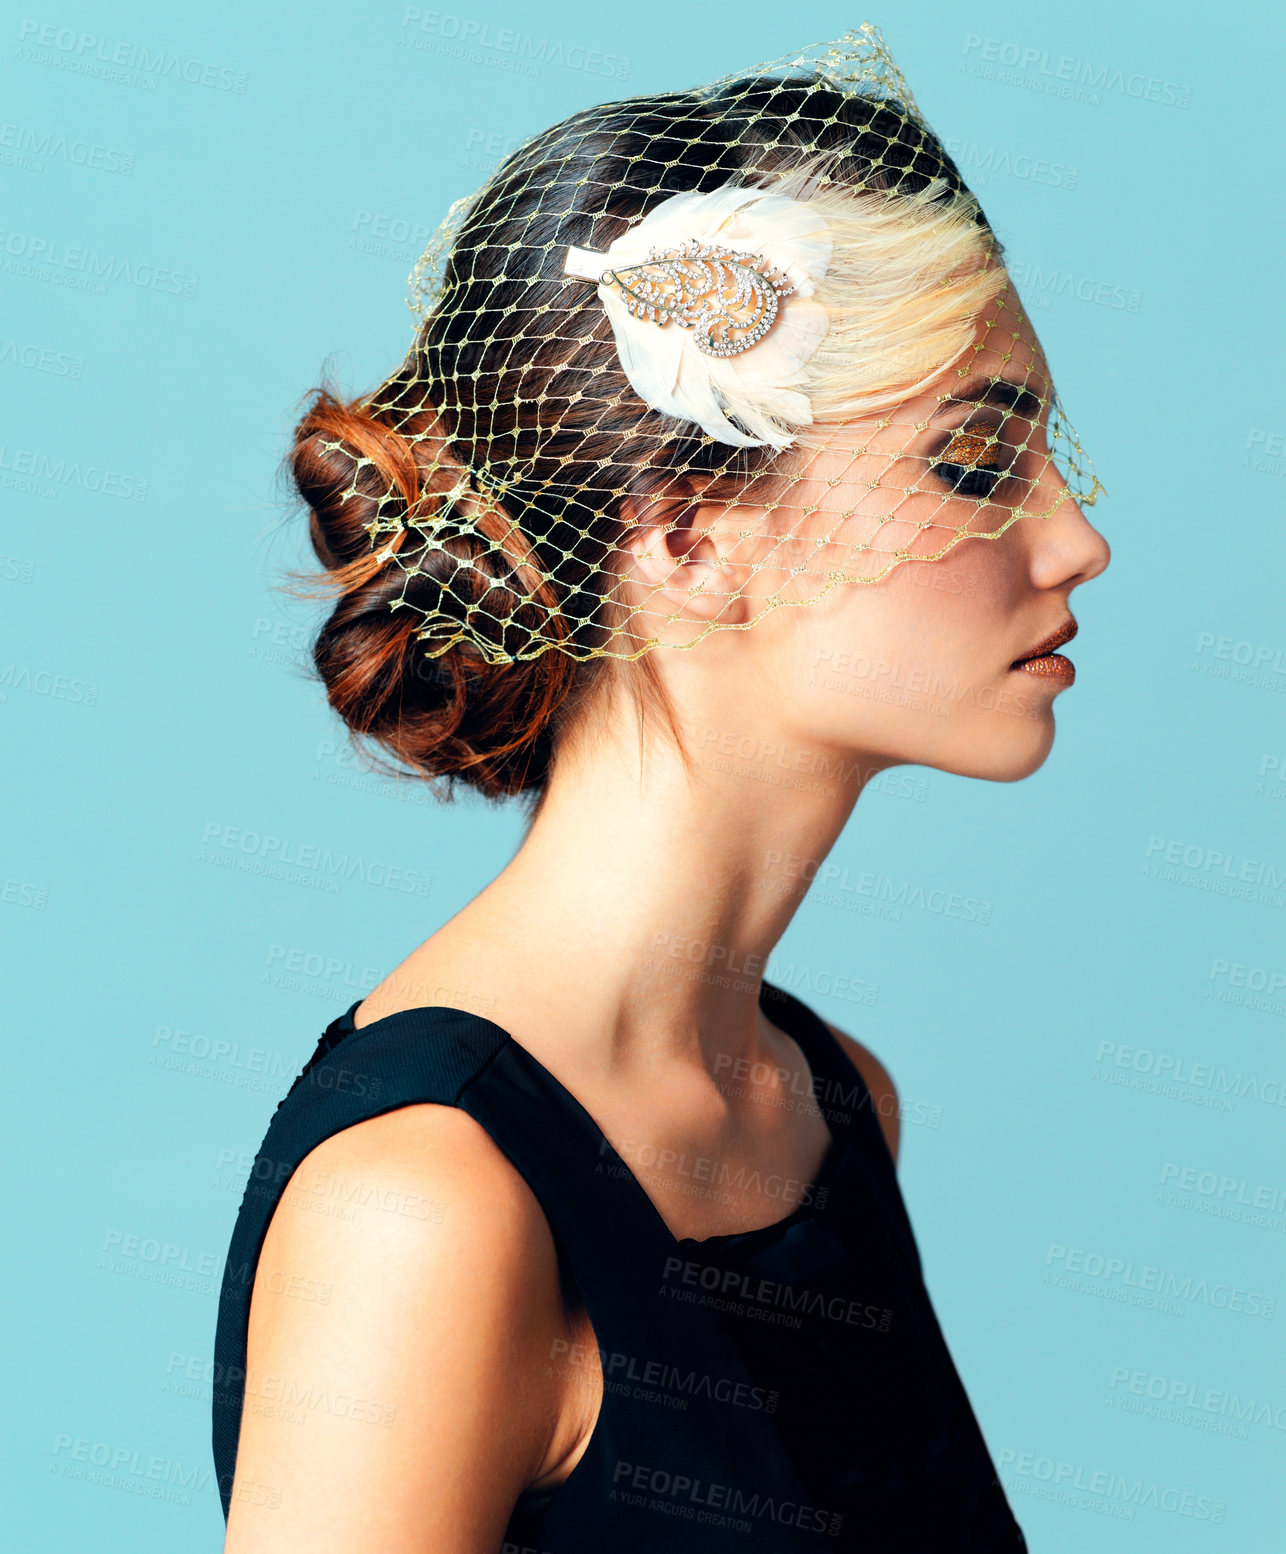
<box><xmin>214</xmin><ymin>30</ymin><xmax>1109</xmax><ymax>1554</ymax></box>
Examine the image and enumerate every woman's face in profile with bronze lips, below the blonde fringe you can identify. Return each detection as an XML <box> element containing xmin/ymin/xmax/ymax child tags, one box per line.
<box><xmin>643</xmin><ymin>285</ymin><xmax>1110</xmax><ymax>782</ymax></box>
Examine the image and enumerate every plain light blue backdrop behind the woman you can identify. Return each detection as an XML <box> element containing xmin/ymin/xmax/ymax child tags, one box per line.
<box><xmin>0</xmin><ymin>0</ymin><xmax>1286</xmax><ymax>1554</ymax></box>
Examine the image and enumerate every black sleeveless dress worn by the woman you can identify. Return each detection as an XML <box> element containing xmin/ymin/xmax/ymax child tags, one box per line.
<box><xmin>214</xmin><ymin>982</ymin><xmax>1027</xmax><ymax>1554</ymax></box>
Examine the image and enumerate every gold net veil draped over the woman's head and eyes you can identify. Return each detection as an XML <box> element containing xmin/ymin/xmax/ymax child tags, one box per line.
<box><xmin>322</xmin><ymin>25</ymin><xmax>1101</xmax><ymax>664</ymax></box>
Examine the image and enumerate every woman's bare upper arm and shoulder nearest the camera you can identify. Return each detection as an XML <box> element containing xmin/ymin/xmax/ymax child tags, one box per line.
<box><xmin>227</xmin><ymin>1105</ymin><xmax>565</xmax><ymax>1554</ymax></box>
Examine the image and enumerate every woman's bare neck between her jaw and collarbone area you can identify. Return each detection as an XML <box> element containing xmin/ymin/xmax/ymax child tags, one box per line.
<box><xmin>426</xmin><ymin>686</ymin><xmax>888</xmax><ymax>1066</ymax></box>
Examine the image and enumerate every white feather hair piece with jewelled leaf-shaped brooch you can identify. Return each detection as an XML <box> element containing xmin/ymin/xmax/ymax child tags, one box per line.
<box><xmin>564</xmin><ymin>183</ymin><xmax>832</xmax><ymax>449</ymax></box>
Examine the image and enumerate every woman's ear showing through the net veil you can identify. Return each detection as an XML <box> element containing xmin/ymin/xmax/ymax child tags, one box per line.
<box><xmin>618</xmin><ymin>477</ymin><xmax>749</xmax><ymax>625</ymax></box>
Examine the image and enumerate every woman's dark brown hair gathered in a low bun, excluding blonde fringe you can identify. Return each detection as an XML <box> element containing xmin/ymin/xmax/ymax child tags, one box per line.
<box><xmin>289</xmin><ymin>78</ymin><xmax>982</xmax><ymax>799</ymax></box>
